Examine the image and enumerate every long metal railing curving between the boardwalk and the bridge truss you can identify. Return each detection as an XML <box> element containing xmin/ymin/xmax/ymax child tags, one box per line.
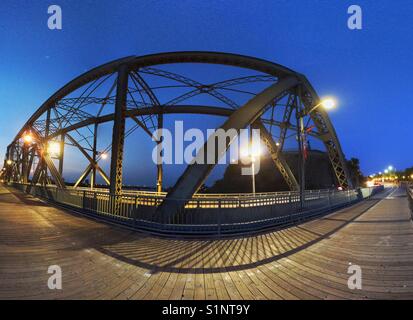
<box><xmin>6</xmin><ymin>183</ymin><xmax>382</xmax><ymax>234</ymax></box>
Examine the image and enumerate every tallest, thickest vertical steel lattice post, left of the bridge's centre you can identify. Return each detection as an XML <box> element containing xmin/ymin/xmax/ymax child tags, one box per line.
<box><xmin>110</xmin><ymin>65</ymin><xmax>129</xmax><ymax>214</ymax></box>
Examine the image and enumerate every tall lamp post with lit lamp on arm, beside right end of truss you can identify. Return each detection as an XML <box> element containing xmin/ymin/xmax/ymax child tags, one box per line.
<box><xmin>297</xmin><ymin>98</ymin><xmax>336</xmax><ymax>208</ymax></box>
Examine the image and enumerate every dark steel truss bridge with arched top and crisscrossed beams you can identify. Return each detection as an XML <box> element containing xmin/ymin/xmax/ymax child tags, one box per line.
<box><xmin>2</xmin><ymin>52</ymin><xmax>352</xmax><ymax>232</ymax></box>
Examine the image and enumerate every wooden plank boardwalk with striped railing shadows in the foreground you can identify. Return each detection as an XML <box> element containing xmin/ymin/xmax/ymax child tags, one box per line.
<box><xmin>0</xmin><ymin>186</ymin><xmax>413</xmax><ymax>299</ymax></box>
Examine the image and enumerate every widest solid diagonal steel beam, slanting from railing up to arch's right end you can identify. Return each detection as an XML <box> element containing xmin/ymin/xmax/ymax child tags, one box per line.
<box><xmin>158</xmin><ymin>77</ymin><xmax>299</xmax><ymax>216</ymax></box>
